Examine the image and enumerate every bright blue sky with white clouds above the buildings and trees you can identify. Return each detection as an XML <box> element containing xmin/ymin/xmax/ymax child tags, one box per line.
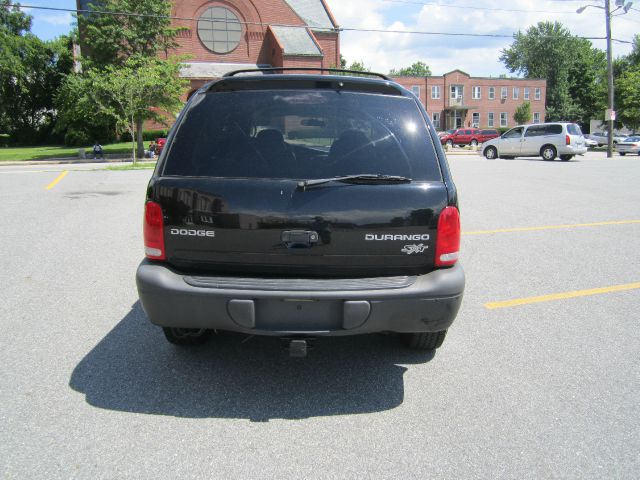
<box><xmin>22</xmin><ymin>0</ymin><xmax>640</xmax><ymax>76</ymax></box>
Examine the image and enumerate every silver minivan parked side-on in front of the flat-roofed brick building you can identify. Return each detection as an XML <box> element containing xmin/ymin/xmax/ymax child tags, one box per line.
<box><xmin>481</xmin><ymin>122</ymin><xmax>587</xmax><ymax>161</ymax></box>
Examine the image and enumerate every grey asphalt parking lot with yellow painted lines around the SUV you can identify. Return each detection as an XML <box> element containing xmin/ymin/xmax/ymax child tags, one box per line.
<box><xmin>0</xmin><ymin>154</ymin><xmax>640</xmax><ymax>479</ymax></box>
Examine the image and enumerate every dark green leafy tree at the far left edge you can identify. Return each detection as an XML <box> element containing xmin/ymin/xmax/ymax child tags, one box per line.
<box><xmin>0</xmin><ymin>0</ymin><xmax>73</xmax><ymax>143</ymax></box>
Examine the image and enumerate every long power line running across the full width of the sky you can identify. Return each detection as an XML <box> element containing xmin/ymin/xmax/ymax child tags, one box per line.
<box><xmin>15</xmin><ymin>5</ymin><xmax>633</xmax><ymax>44</ymax></box>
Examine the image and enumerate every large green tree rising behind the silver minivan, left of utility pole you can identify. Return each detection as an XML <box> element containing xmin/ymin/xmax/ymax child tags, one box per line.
<box><xmin>500</xmin><ymin>22</ymin><xmax>606</xmax><ymax>122</ymax></box>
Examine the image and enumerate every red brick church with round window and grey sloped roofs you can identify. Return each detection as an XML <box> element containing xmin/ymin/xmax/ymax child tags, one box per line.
<box><xmin>77</xmin><ymin>0</ymin><xmax>340</xmax><ymax>95</ymax></box>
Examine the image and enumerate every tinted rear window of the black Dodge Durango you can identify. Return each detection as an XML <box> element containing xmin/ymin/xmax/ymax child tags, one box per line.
<box><xmin>163</xmin><ymin>90</ymin><xmax>442</xmax><ymax>181</ymax></box>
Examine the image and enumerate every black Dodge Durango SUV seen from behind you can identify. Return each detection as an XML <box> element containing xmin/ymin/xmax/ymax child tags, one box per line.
<box><xmin>136</xmin><ymin>71</ymin><xmax>464</xmax><ymax>352</ymax></box>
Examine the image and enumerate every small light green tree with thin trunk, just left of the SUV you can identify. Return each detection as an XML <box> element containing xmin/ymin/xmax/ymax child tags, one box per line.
<box><xmin>85</xmin><ymin>55</ymin><xmax>186</xmax><ymax>162</ymax></box>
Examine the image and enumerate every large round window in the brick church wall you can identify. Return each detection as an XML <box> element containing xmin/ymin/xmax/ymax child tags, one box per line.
<box><xmin>198</xmin><ymin>7</ymin><xmax>242</xmax><ymax>54</ymax></box>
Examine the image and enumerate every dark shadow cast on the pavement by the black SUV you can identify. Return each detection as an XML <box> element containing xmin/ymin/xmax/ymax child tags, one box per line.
<box><xmin>69</xmin><ymin>302</ymin><xmax>433</xmax><ymax>422</ymax></box>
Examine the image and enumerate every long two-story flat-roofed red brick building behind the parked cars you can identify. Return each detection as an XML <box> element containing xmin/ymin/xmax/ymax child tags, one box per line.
<box><xmin>394</xmin><ymin>70</ymin><xmax>547</xmax><ymax>130</ymax></box>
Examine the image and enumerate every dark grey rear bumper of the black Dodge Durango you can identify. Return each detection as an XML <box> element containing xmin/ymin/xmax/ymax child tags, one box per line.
<box><xmin>136</xmin><ymin>260</ymin><xmax>465</xmax><ymax>336</ymax></box>
